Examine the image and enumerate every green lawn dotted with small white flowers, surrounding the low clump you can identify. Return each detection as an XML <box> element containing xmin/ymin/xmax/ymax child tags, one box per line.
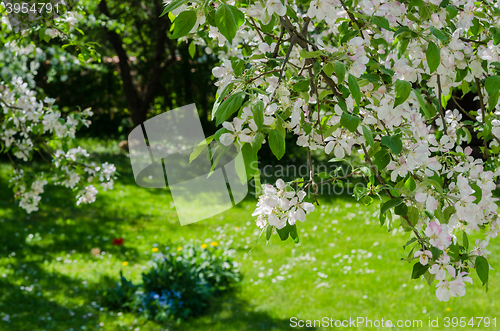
<box><xmin>0</xmin><ymin>147</ymin><xmax>500</xmax><ymax>331</ymax></box>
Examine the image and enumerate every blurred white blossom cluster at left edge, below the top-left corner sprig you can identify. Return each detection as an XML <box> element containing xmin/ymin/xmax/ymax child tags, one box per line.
<box><xmin>0</xmin><ymin>42</ymin><xmax>116</xmax><ymax>213</ymax></box>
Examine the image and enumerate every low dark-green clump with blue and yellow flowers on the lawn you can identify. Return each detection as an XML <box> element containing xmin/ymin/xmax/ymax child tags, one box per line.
<box><xmin>102</xmin><ymin>242</ymin><xmax>240</xmax><ymax>322</ymax></box>
